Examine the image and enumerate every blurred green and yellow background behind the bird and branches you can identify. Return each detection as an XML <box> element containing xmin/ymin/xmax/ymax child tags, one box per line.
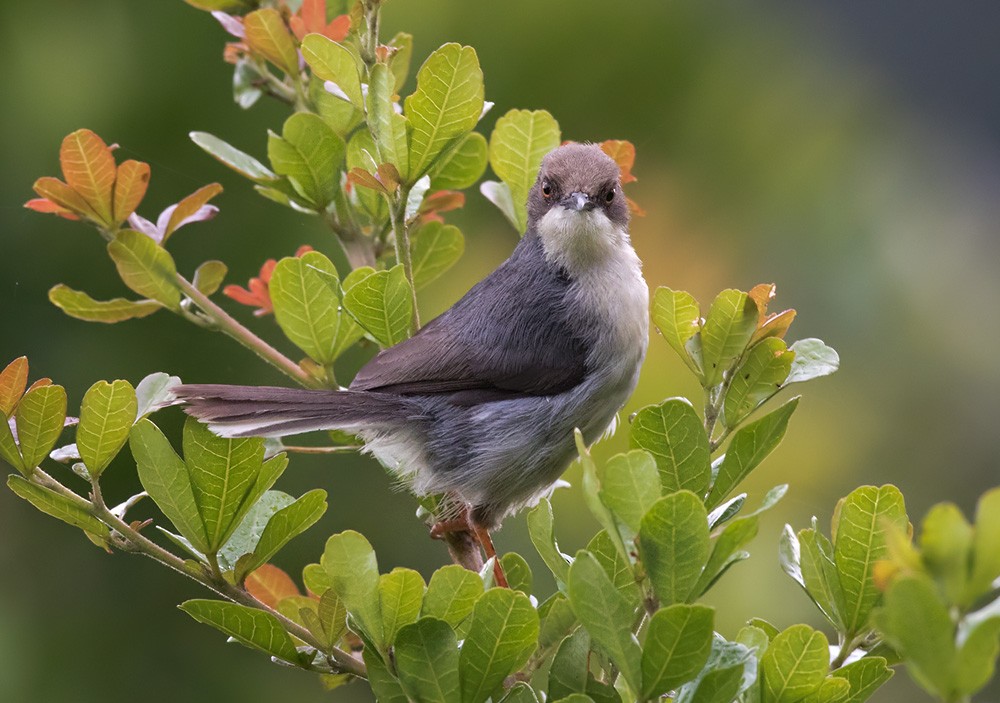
<box><xmin>0</xmin><ymin>0</ymin><xmax>1000</xmax><ymax>703</ymax></box>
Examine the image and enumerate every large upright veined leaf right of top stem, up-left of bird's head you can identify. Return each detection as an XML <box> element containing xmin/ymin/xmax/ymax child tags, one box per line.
<box><xmin>405</xmin><ymin>44</ymin><xmax>483</xmax><ymax>182</ymax></box>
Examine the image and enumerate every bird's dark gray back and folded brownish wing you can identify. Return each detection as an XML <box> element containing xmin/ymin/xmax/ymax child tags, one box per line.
<box><xmin>351</xmin><ymin>235</ymin><xmax>586</xmax><ymax>405</ymax></box>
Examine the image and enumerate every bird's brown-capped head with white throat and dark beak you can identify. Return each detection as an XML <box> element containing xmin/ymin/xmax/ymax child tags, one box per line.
<box><xmin>528</xmin><ymin>144</ymin><xmax>629</xmax><ymax>274</ymax></box>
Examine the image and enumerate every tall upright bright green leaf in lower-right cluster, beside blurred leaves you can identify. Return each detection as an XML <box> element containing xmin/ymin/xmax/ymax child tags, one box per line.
<box><xmin>833</xmin><ymin>485</ymin><xmax>908</xmax><ymax>635</ymax></box>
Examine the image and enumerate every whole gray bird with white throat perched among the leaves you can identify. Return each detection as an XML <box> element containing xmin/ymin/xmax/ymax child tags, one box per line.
<box><xmin>174</xmin><ymin>143</ymin><xmax>649</xmax><ymax>576</ymax></box>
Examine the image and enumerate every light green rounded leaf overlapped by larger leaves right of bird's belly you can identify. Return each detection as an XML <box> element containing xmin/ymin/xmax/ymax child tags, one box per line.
<box><xmin>598</xmin><ymin>449</ymin><xmax>660</xmax><ymax>533</ymax></box>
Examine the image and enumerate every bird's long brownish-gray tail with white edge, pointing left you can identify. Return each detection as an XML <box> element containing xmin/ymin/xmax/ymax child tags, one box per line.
<box><xmin>173</xmin><ymin>384</ymin><xmax>415</xmax><ymax>437</ymax></box>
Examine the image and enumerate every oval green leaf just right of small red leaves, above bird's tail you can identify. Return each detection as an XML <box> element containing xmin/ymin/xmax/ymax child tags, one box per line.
<box><xmin>269</xmin><ymin>252</ymin><xmax>341</xmax><ymax>366</ymax></box>
